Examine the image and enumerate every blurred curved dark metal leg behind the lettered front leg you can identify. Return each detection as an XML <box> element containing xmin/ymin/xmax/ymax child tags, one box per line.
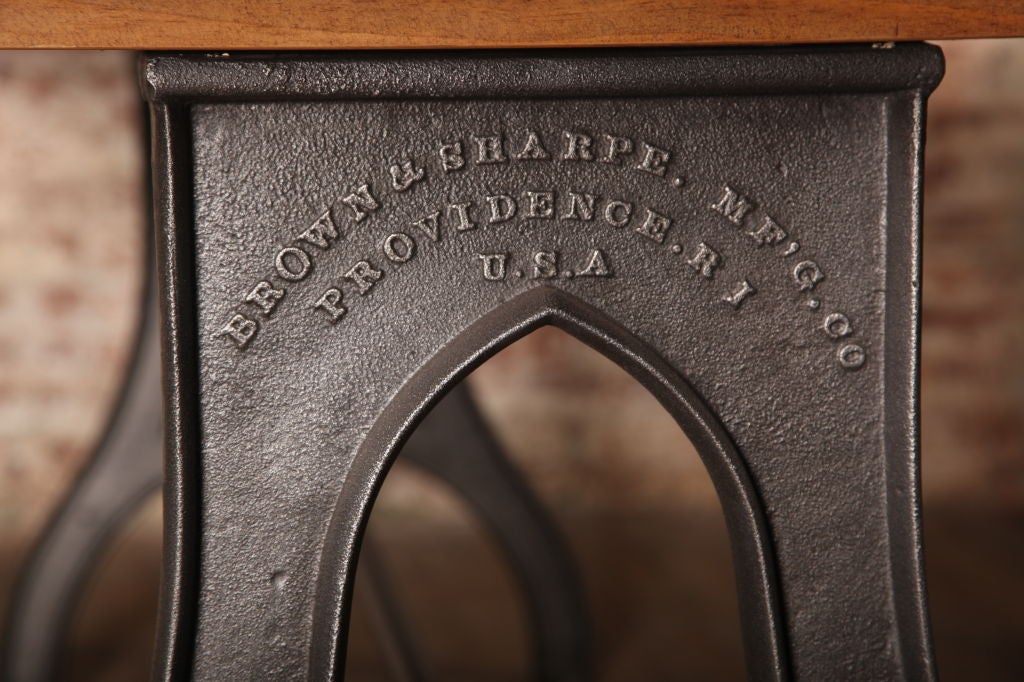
<box><xmin>0</xmin><ymin>290</ymin><xmax>590</xmax><ymax>682</ymax></box>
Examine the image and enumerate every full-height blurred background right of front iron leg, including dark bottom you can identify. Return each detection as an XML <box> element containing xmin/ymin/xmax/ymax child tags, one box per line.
<box><xmin>922</xmin><ymin>40</ymin><xmax>1024</xmax><ymax>680</ymax></box>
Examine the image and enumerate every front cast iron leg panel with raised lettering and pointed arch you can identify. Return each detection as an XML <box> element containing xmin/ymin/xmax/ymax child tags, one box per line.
<box><xmin>142</xmin><ymin>45</ymin><xmax>942</xmax><ymax>680</ymax></box>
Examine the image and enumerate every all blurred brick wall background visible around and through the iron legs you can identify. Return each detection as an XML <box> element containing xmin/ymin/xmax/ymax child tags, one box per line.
<box><xmin>0</xmin><ymin>41</ymin><xmax>1024</xmax><ymax>680</ymax></box>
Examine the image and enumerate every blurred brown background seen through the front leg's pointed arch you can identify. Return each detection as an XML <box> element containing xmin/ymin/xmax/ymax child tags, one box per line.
<box><xmin>346</xmin><ymin>327</ymin><xmax>744</xmax><ymax>682</ymax></box>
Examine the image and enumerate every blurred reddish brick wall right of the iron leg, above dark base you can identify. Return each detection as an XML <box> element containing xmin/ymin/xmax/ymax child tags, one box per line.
<box><xmin>922</xmin><ymin>40</ymin><xmax>1024</xmax><ymax>505</ymax></box>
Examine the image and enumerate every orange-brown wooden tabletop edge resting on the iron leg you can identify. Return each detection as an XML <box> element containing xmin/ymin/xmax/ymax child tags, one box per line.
<box><xmin>0</xmin><ymin>0</ymin><xmax>1024</xmax><ymax>50</ymax></box>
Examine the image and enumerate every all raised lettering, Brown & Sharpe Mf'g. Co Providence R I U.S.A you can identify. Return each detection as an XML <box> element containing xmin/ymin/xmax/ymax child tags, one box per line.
<box><xmin>218</xmin><ymin>130</ymin><xmax>867</xmax><ymax>370</ymax></box>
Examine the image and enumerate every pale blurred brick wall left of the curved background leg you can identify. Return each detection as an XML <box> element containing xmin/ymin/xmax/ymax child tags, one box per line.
<box><xmin>0</xmin><ymin>52</ymin><xmax>144</xmax><ymax>600</ymax></box>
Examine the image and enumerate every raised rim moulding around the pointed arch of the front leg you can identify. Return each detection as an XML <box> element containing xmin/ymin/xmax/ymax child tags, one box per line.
<box><xmin>309</xmin><ymin>287</ymin><xmax>787</xmax><ymax>680</ymax></box>
